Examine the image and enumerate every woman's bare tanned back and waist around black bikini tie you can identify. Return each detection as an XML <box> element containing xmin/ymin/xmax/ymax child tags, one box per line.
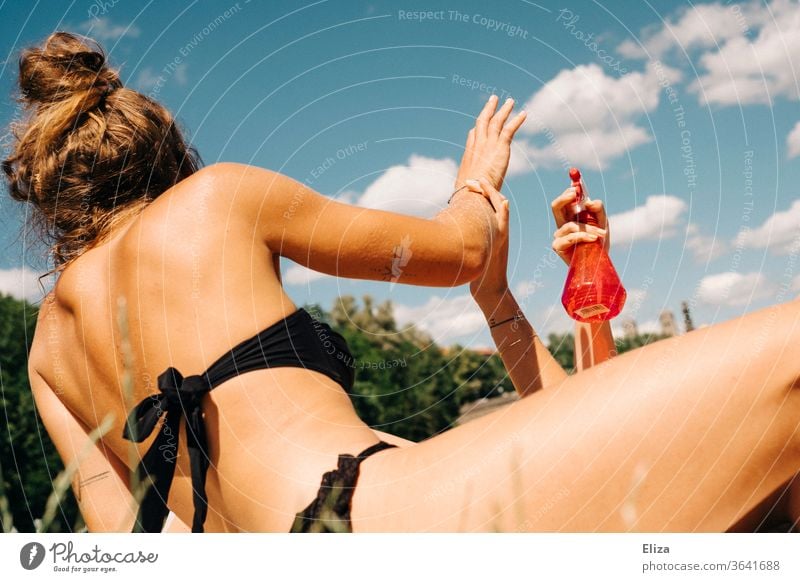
<box><xmin>30</xmin><ymin>171</ymin><xmax>390</xmax><ymax>531</ymax></box>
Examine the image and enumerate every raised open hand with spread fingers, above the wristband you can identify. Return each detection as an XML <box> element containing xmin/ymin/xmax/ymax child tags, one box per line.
<box><xmin>456</xmin><ymin>95</ymin><xmax>525</xmax><ymax>190</ymax></box>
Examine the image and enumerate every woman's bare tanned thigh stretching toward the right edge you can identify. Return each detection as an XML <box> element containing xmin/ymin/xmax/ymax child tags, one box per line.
<box><xmin>352</xmin><ymin>301</ymin><xmax>800</xmax><ymax>532</ymax></box>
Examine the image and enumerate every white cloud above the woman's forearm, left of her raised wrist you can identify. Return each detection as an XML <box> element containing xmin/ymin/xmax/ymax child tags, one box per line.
<box><xmin>357</xmin><ymin>154</ymin><xmax>458</xmax><ymax>217</ymax></box>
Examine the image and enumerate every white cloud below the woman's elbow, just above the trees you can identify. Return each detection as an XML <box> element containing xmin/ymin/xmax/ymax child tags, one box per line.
<box><xmin>394</xmin><ymin>295</ymin><xmax>486</xmax><ymax>345</ymax></box>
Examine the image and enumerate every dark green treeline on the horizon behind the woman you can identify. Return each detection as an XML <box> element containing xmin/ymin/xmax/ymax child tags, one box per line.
<box><xmin>0</xmin><ymin>294</ymin><xmax>659</xmax><ymax>531</ymax></box>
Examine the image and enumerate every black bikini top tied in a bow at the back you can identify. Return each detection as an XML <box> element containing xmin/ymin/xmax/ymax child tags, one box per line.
<box><xmin>122</xmin><ymin>308</ymin><xmax>355</xmax><ymax>532</ymax></box>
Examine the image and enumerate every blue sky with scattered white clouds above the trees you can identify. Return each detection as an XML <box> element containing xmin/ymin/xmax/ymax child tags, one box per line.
<box><xmin>0</xmin><ymin>0</ymin><xmax>800</xmax><ymax>346</ymax></box>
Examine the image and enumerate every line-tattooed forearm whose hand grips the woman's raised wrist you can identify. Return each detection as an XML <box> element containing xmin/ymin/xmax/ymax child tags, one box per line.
<box><xmin>470</xmin><ymin>181</ymin><xmax>567</xmax><ymax>397</ymax></box>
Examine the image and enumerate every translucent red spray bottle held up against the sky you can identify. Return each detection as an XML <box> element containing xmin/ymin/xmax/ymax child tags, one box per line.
<box><xmin>561</xmin><ymin>168</ymin><xmax>627</xmax><ymax>323</ymax></box>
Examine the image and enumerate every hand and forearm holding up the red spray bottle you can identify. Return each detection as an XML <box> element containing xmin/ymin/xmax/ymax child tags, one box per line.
<box><xmin>552</xmin><ymin>188</ymin><xmax>617</xmax><ymax>372</ymax></box>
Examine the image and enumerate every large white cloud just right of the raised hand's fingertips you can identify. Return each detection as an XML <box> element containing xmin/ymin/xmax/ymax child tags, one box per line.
<box><xmin>509</xmin><ymin>63</ymin><xmax>680</xmax><ymax>175</ymax></box>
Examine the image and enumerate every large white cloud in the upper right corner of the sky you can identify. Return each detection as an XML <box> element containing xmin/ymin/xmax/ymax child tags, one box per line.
<box><xmin>620</xmin><ymin>0</ymin><xmax>800</xmax><ymax>105</ymax></box>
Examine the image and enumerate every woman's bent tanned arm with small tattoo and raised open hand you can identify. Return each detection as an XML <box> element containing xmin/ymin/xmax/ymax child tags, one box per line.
<box><xmin>209</xmin><ymin>94</ymin><xmax>524</xmax><ymax>286</ymax></box>
